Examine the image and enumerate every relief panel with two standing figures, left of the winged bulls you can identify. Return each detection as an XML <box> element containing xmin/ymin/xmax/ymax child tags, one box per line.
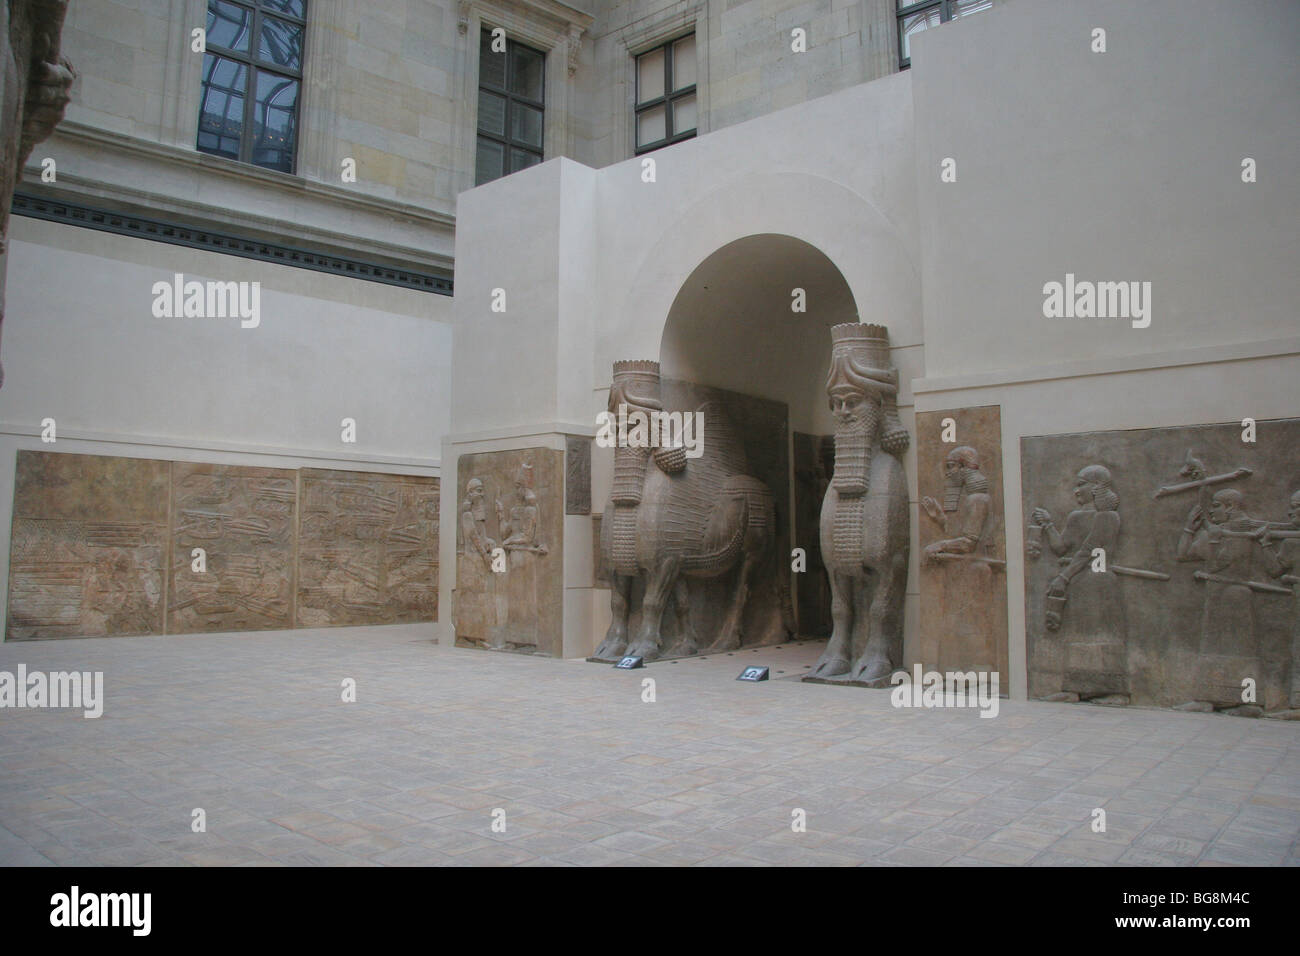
<box><xmin>455</xmin><ymin>447</ymin><xmax>564</xmax><ymax>657</ymax></box>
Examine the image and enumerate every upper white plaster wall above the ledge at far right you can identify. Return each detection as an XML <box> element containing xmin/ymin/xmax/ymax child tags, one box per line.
<box><xmin>911</xmin><ymin>0</ymin><xmax>1300</xmax><ymax>377</ymax></box>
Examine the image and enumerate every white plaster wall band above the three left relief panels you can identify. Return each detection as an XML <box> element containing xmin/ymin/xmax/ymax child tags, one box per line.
<box><xmin>0</xmin><ymin>216</ymin><xmax>451</xmax><ymax>464</ymax></box>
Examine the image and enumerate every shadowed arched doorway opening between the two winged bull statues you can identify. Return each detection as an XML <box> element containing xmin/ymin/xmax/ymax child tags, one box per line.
<box><xmin>659</xmin><ymin>233</ymin><xmax>858</xmax><ymax>637</ymax></box>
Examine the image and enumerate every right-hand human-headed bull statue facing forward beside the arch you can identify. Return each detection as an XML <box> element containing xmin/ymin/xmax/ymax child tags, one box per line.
<box><xmin>809</xmin><ymin>323</ymin><xmax>910</xmax><ymax>687</ymax></box>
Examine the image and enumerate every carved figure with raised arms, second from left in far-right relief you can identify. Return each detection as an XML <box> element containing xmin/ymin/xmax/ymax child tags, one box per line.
<box><xmin>1178</xmin><ymin>488</ymin><xmax>1268</xmax><ymax>708</ymax></box>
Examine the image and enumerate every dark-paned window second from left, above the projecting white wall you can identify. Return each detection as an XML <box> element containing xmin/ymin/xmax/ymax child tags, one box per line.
<box><xmin>475</xmin><ymin>29</ymin><xmax>546</xmax><ymax>186</ymax></box>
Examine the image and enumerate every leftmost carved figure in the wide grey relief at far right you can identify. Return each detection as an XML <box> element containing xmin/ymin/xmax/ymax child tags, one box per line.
<box><xmin>1028</xmin><ymin>464</ymin><xmax>1128</xmax><ymax>704</ymax></box>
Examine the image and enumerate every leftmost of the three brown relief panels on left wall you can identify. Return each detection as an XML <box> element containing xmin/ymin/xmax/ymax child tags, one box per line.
<box><xmin>7</xmin><ymin>451</ymin><xmax>172</xmax><ymax>640</ymax></box>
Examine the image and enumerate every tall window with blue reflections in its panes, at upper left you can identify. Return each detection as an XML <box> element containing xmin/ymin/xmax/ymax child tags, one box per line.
<box><xmin>196</xmin><ymin>0</ymin><xmax>307</xmax><ymax>173</ymax></box>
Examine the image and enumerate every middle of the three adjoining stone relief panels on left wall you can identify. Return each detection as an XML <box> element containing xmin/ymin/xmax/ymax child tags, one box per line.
<box><xmin>168</xmin><ymin>462</ymin><xmax>298</xmax><ymax>633</ymax></box>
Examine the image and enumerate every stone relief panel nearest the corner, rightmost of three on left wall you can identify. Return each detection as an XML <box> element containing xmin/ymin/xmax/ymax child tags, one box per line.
<box><xmin>296</xmin><ymin>468</ymin><xmax>438</xmax><ymax>627</ymax></box>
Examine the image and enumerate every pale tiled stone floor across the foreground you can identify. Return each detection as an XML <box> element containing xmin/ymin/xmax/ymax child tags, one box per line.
<box><xmin>0</xmin><ymin>626</ymin><xmax>1300</xmax><ymax>865</ymax></box>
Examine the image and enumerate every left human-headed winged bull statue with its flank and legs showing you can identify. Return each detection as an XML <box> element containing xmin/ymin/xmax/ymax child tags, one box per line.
<box><xmin>594</xmin><ymin>362</ymin><xmax>793</xmax><ymax>661</ymax></box>
